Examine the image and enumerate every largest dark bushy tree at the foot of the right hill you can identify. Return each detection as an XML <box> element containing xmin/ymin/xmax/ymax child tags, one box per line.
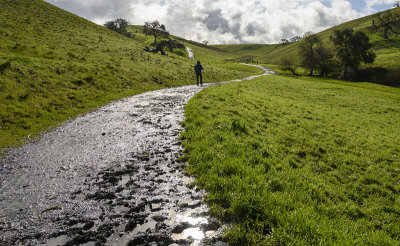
<box><xmin>331</xmin><ymin>28</ymin><xmax>376</xmax><ymax>79</ymax></box>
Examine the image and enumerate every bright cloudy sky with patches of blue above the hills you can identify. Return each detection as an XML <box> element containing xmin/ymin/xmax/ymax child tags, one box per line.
<box><xmin>45</xmin><ymin>0</ymin><xmax>395</xmax><ymax>44</ymax></box>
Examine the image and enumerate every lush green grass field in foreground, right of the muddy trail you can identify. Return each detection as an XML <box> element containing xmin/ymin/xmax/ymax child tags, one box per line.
<box><xmin>182</xmin><ymin>76</ymin><xmax>400</xmax><ymax>245</ymax></box>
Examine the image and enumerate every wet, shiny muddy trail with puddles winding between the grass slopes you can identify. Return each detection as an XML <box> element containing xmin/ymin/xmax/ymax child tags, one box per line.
<box><xmin>0</xmin><ymin>64</ymin><xmax>272</xmax><ymax>245</ymax></box>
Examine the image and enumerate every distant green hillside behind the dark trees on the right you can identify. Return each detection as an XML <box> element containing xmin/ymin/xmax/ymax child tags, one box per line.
<box><xmin>213</xmin><ymin>8</ymin><xmax>400</xmax><ymax>86</ymax></box>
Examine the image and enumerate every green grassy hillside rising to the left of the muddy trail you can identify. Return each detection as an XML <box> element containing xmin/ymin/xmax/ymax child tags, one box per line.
<box><xmin>0</xmin><ymin>0</ymin><xmax>258</xmax><ymax>149</ymax></box>
